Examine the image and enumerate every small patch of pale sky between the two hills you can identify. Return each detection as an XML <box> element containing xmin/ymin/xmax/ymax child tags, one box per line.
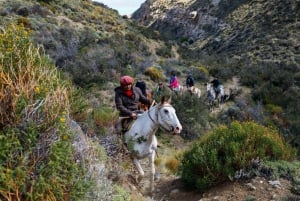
<box><xmin>94</xmin><ymin>0</ymin><xmax>146</xmax><ymax>15</ymax></box>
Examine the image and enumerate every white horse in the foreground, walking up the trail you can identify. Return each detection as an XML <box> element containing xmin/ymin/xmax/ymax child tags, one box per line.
<box><xmin>125</xmin><ymin>97</ymin><xmax>182</xmax><ymax>192</ymax></box>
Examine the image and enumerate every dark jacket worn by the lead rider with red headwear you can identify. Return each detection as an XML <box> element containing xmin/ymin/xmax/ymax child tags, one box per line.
<box><xmin>115</xmin><ymin>87</ymin><xmax>151</xmax><ymax>116</ymax></box>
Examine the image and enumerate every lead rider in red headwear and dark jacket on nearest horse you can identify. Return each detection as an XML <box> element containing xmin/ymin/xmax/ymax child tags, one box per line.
<box><xmin>115</xmin><ymin>75</ymin><xmax>151</xmax><ymax>133</ymax></box>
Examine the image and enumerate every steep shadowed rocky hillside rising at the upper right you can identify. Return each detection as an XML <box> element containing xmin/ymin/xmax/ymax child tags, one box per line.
<box><xmin>132</xmin><ymin>0</ymin><xmax>300</xmax><ymax>146</ymax></box>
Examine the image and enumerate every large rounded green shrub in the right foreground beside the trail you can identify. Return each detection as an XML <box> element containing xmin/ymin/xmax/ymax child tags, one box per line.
<box><xmin>181</xmin><ymin>122</ymin><xmax>295</xmax><ymax>191</ymax></box>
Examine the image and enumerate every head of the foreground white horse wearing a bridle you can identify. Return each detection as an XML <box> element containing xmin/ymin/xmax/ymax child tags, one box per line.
<box><xmin>157</xmin><ymin>97</ymin><xmax>182</xmax><ymax>133</ymax></box>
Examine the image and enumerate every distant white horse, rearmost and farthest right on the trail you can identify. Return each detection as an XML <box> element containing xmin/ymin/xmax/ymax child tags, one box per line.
<box><xmin>206</xmin><ymin>83</ymin><xmax>227</xmax><ymax>111</ymax></box>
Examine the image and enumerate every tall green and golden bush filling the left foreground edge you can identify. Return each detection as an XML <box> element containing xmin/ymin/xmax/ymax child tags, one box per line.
<box><xmin>0</xmin><ymin>25</ymin><xmax>88</xmax><ymax>200</ymax></box>
